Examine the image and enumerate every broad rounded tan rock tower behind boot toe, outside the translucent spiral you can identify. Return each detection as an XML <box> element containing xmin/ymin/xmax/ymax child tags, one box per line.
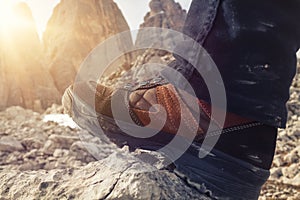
<box><xmin>43</xmin><ymin>0</ymin><xmax>133</xmax><ymax>93</ymax></box>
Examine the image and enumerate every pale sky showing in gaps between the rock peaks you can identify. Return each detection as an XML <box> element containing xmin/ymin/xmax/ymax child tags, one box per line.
<box><xmin>19</xmin><ymin>0</ymin><xmax>192</xmax><ymax>36</ymax></box>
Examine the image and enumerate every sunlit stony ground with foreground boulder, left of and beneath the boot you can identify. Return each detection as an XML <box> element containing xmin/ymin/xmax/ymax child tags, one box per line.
<box><xmin>0</xmin><ymin>106</ymin><xmax>209</xmax><ymax>199</ymax></box>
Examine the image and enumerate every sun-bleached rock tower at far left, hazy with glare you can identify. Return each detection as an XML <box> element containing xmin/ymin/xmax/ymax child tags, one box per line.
<box><xmin>0</xmin><ymin>3</ymin><xmax>60</xmax><ymax>112</ymax></box>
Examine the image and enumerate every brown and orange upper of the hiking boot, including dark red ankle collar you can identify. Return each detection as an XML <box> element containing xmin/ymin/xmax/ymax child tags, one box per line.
<box><xmin>62</xmin><ymin>78</ymin><xmax>249</xmax><ymax>141</ymax></box>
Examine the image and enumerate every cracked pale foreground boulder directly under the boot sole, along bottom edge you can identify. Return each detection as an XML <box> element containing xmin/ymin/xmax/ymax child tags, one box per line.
<box><xmin>0</xmin><ymin>154</ymin><xmax>210</xmax><ymax>200</ymax></box>
